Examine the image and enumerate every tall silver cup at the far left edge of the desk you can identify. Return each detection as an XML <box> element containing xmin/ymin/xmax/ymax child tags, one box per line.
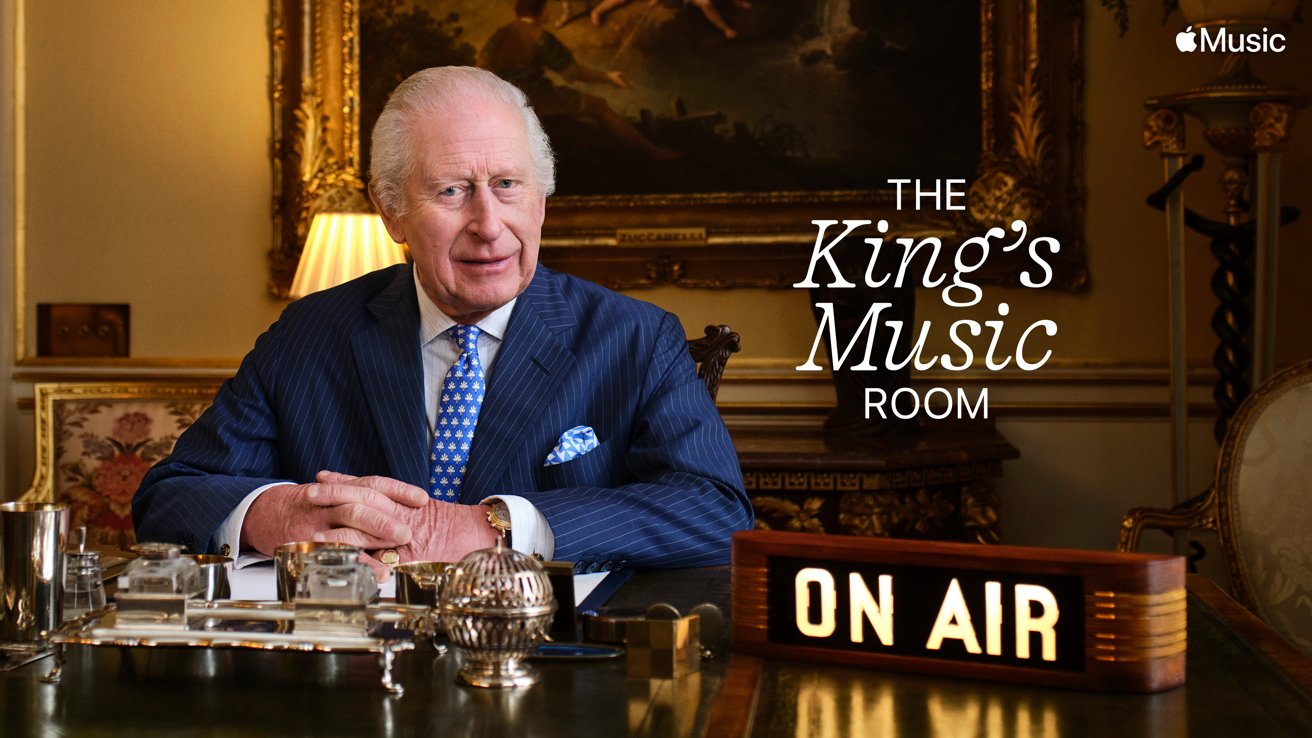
<box><xmin>0</xmin><ymin>502</ymin><xmax>68</xmax><ymax>643</ymax></box>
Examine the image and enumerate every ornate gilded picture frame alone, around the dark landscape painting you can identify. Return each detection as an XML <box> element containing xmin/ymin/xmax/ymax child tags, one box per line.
<box><xmin>269</xmin><ymin>0</ymin><xmax>1089</xmax><ymax>295</ymax></box>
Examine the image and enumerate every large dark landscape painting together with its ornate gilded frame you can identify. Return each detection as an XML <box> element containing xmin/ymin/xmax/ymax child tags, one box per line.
<box><xmin>270</xmin><ymin>0</ymin><xmax>1088</xmax><ymax>294</ymax></box>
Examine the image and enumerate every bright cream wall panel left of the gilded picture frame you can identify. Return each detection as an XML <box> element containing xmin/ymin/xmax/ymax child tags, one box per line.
<box><xmin>24</xmin><ymin>0</ymin><xmax>281</xmax><ymax>358</ymax></box>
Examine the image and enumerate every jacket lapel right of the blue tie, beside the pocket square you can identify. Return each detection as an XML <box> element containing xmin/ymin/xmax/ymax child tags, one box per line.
<box><xmin>461</xmin><ymin>267</ymin><xmax>575</xmax><ymax>503</ymax></box>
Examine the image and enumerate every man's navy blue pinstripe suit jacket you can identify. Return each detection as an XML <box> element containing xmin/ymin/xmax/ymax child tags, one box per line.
<box><xmin>133</xmin><ymin>265</ymin><xmax>752</xmax><ymax>570</ymax></box>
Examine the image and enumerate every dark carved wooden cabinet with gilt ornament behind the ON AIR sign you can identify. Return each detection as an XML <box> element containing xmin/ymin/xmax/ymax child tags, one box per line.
<box><xmin>732</xmin><ymin>423</ymin><xmax>1021</xmax><ymax>544</ymax></box>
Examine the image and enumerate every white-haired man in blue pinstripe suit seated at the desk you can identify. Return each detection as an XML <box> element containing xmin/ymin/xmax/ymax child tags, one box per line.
<box><xmin>133</xmin><ymin>67</ymin><xmax>752</xmax><ymax>573</ymax></box>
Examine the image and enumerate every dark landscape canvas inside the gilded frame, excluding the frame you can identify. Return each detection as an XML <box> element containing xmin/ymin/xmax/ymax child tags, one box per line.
<box><xmin>359</xmin><ymin>0</ymin><xmax>980</xmax><ymax>196</ymax></box>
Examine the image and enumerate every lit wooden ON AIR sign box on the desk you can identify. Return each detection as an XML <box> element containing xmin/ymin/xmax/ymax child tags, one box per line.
<box><xmin>732</xmin><ymin>531</ymin><xmax>1186</xmax><ymax>692</ymax></box>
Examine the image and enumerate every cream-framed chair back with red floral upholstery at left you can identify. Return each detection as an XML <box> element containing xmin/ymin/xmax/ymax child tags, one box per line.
<box><xmin>20</xmin><ymin>382</ymin><xmax>219</xmax><ymax>550</ymax></box>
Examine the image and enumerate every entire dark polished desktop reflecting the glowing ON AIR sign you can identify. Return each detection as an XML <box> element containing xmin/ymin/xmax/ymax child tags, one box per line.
<box><xmin>0</xmin><ymin>570</ymin><xmax>1312</xmax><ymax>738</ymax></box>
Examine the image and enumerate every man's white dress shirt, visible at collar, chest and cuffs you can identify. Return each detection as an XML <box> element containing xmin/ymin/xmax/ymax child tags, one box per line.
<box><xmin>218</xmin><ymin>270</ymin><xmax>556</xmax><ymax>569</ymax></box>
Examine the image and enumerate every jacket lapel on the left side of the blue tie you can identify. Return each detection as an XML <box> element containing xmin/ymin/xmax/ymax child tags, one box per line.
<box><xmin>350</xmin><ymin>269</ymin><xmax>428</xmax><ymax>488</ymax></box>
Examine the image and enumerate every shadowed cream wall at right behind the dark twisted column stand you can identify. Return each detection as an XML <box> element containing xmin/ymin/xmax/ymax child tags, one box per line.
<box><xmin>1075</xmin><ymin>3</ymin><xmax>1312</xmax><ymax>364</ymax></box>
